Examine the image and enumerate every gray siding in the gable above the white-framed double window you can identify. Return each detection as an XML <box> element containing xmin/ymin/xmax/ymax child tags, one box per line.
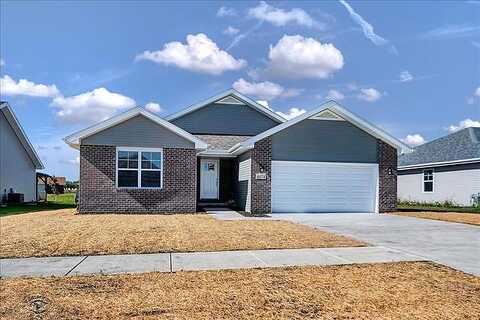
<box><xmin>81</xmin><ymin>115</ymin><xmax>194</xmax><ymax>149</ymax></box>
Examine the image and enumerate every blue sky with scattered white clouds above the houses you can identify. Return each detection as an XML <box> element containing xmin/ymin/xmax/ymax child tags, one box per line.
<box><xmin>0</xmin><ymin>0</ymin><xmax>480</xmax><ymax>180</ymax></box>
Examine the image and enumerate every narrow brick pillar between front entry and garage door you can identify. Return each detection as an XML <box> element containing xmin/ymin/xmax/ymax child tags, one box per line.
<box><xmin>251</xmin><ymin>137</ymin><xmax>272</xmax><ymax>214</ymax></box>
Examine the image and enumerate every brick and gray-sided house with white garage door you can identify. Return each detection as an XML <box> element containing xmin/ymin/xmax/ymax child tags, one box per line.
<box><xmin>65</xmin><ymin>90</ymin><xmax>408</xmax><ymax>213</ymax></box>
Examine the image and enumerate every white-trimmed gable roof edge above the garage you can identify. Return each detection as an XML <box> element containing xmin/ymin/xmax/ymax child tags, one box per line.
<box><xmin>229</xmin><ymin>100</ymin><xmax>411</xmax><ymax>154</ymax></box>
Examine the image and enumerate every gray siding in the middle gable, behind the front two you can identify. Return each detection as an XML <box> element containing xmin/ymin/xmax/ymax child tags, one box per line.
<box><xmin>171</xmin><ymin>103</ymin><xmax>279</xmax><ymax>136</ymax></box>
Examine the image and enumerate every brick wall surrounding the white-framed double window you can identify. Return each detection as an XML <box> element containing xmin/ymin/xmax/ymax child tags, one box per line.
<box><xmin>79</xmin><ymin>145</ymin><xmax>197</xmax><ymax>213</ymax></box>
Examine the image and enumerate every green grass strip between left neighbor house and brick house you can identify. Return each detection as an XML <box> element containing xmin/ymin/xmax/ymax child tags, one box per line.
<box><xmin>0</xmin><ymin>193</ymin><xmax>76</xmax><ymax>217</ymax></box>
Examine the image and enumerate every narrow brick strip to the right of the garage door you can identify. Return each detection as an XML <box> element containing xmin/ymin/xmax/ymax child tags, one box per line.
<box><xmin>377</xmin><ymin>140</ymin><xmax>397</xmax><ymax>212</ymax></box>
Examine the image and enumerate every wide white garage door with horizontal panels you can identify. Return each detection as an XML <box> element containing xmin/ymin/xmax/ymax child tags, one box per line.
<box><xmin>272</xmin><ymin>161</ymin><xmax>378</xmax><ymax>212</ymax></box>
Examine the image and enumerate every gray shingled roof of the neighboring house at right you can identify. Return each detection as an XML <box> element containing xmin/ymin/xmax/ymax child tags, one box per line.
<box><xmin>398</xmin><ymin>128</ymin><xmax>480</xmax><ymax>168</ymax></box>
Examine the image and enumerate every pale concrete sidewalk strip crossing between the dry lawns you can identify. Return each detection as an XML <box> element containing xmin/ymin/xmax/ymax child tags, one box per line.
<box><xmin>0</xmin><ymin>247</ymin><xmax>423</xmax><ymax>278</ymax></box>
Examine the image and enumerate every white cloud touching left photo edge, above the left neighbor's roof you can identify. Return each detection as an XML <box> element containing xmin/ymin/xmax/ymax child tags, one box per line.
<box><xmin>0</xmin><ymin>75</ymin><xmax>60</xmax><ymax>97</ymax></box>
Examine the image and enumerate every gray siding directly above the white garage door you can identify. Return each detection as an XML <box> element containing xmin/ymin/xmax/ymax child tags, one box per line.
<box><xmin>272</xmin><ymin>120</ymin><xmax>377</xmax><ymax>163</ymax></box>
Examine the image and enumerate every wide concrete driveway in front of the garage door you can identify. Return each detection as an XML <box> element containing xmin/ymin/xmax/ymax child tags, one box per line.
<box><xmin>272</xmin><ymin>213</ymin><xmax>480</xmax><ymax>276</ymax></box>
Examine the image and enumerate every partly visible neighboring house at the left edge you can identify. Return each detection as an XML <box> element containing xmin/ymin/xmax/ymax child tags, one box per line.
<box><xmin>0</xmin><ymin>102</ymin><xmax>43</xmax><ymax>202</ymax></box>
